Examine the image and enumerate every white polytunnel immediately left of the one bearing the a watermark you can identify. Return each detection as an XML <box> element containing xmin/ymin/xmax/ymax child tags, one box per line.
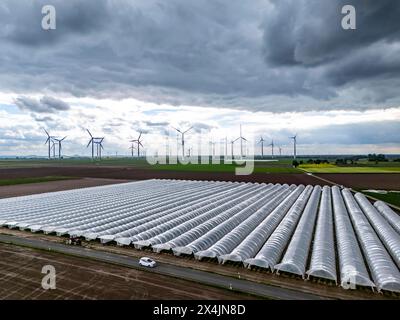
<box><xmin>307</xmin><ymin>186</ymin><xmax>337</xmax><ymax>283</ymax></box>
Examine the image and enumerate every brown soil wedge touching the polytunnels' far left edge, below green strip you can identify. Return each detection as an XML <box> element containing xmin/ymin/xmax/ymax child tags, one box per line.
<box><xmin>0</xmin><ymin>178</ymin><xmax>129</xmax><ymax>199</ymax></box>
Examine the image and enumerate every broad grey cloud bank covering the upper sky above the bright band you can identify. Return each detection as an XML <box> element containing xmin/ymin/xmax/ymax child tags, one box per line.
<box><xmin>0</xmin><ymin>0</ymin><xmax>400</xmax><ymax>112</ymax></box>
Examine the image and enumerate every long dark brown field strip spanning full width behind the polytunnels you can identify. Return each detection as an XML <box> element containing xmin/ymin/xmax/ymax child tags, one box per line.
<box><xmin>0</xmin><ymin>166</ymin><xmax>400</xmax><ymax>190</ymax></box>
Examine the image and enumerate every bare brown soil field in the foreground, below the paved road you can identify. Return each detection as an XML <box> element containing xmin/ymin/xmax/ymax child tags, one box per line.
<box><xmin>0</xmin><ymin>244</ymin><xmax>254</xmax><ymax>300</ymax></box>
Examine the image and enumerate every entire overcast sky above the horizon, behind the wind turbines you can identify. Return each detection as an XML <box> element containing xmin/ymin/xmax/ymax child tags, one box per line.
<box><xmin>0</xmin><ymin>0</ymin><xmax>400</xmax><ymax>155</ymax></box>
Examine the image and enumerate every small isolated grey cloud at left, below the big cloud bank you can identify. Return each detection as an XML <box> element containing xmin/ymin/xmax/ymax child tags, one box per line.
<box><xmin>14</xmin><ymin>96</ymin><xmax>70</xmax><ymax>113</ymax></box>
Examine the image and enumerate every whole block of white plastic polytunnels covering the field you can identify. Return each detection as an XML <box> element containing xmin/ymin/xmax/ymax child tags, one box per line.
<box><xmin>0</xmin><ymin>179</ymin><xmax>400</xmax><ymax>292</ymax></box>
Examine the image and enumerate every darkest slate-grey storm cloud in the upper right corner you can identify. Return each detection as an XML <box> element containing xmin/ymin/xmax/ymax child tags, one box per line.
<box><xmin>263</xmin><ymin>0</ymin><xmax>400</xmax><ymax>86</ymax></box>
